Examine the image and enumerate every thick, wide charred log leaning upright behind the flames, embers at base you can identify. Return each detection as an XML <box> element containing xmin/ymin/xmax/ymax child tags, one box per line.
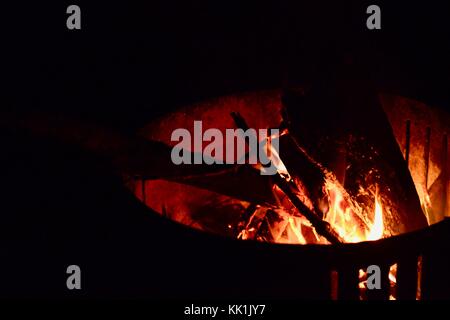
<box><xmin>283</xmin><ymin>71</ymin><xmax>427</xmax><ymax>235</ymax></box>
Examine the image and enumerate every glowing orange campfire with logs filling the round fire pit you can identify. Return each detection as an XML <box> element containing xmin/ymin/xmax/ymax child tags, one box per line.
<box><xmin>129</xmin><ymin>80</ymin><xmax>448</xmax><ymax>298</ymax></box>
